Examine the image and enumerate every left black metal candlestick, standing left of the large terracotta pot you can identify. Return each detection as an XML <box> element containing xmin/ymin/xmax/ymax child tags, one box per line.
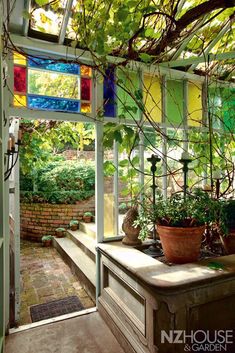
<box><xmin>144</xmin><ymin>154</ymin><xmax>163</xmax><ymax>257</ymax></box>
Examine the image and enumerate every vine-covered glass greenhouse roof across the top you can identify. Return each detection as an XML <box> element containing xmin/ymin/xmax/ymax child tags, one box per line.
<box><xmin>5</xmin><ymin>0</ymin><xmax>235</xmax><ymax>81</ymax></box>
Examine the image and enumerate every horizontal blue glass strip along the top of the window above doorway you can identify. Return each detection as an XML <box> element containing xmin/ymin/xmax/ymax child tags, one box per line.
<box><xmin>28</xmin><ymin>57</ymin><xmax>80</xmax><ymax>75</ymax></box>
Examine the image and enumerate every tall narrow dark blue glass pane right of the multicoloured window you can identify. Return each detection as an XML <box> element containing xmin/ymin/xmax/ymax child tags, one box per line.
<box><xmin>104</xmin><ymin>69</ymin><xmax>116</xmax><ymax>117</ymax></box>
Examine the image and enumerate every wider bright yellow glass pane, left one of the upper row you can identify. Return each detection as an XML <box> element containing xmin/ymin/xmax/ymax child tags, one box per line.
<box><xmin>143</xmin><ymin>76</ymin><xmax>162</xmax><ymax>122</ymax></box>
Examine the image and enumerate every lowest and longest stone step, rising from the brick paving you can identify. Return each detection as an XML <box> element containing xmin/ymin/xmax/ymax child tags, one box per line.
<box><xmin>53</xmin><ymin>237</ymin><xmax>96</xmax><ymax>300</ymax></box>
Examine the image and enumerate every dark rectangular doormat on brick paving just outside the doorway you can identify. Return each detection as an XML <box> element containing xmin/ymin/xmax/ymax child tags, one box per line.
<box><xmin>30</xmin><ymin>296</ymin><xmax>84</xmax><ymax>322</ymax></box>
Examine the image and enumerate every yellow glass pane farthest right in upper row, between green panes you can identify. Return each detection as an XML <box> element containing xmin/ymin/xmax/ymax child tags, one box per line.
<box><xmin>188</xmin><ymin>82</ymin><xmax>202</xmax><ymax>126</ymax></box>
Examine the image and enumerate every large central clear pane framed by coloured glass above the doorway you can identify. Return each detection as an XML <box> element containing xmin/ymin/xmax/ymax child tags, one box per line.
<box><xmin>28</xmin><ymin>69</ymin><xmax>80</xmax><ymax>99</ymax></box>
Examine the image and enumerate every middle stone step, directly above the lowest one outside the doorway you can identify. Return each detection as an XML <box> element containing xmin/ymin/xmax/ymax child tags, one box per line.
<box><xmin>67</xmin><ymin>229</ymin><xmax>96</xmax><ymax>262</ymax></box>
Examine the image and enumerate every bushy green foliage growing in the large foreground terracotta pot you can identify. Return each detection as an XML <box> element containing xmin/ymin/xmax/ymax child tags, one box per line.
<box><xmin>134</xmin><ymin>189</ymin><xmax>227</xmax><ymax>240</ymax></box>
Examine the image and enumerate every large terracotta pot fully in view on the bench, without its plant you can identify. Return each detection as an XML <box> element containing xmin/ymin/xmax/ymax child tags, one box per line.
<box><xmin>157</xmin><ymin>225</ymin><xmax>205</xmax><ymax>264</ymax></box>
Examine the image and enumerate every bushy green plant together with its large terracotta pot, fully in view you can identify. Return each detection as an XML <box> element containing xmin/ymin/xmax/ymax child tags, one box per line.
<box><xmin>137</xmin><ymin>189</ymin><xmax>224</xmax><ymax>264</ymax></box>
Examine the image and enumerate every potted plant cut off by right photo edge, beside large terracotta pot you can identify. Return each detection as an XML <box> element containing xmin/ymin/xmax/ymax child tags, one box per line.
<box><xmin>220</xmin><ymin>200</ymin><xmax>235</xmax><ymax>254</ymax></box>
